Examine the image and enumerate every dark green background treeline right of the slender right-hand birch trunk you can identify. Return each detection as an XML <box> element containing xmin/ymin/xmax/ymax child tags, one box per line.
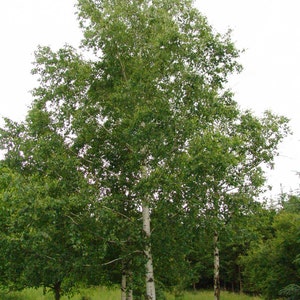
<box><xmin>191</xmin><ymin>195</ymin><xmax>300</xmax><ymax>299</ymax></box>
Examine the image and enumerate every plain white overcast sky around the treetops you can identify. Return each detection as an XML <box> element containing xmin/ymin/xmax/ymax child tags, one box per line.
<box><xmin>0</xmin><ymin>0</ymin><xmax>300</xmax><ymax>196</ymax></box>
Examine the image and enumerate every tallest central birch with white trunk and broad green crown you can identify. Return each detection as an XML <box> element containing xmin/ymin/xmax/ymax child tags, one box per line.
<box><xmin>28</xmin><ymin>0</ymin><xmax>243</xmax><ymax>299</ymax></box>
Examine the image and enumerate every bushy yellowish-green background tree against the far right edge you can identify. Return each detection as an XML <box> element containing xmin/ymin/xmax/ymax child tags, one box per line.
<box><xmin>242</xmin><ymin>196</ymin><xmax>300</xmax><ymax>299</ymax></box>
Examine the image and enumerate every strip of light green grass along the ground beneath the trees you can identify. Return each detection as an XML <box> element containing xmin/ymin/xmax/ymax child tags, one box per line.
<box><xmin>0</xmin><ymin>287</ymin><xmax>261</xmax><ymax>300</ymax></box>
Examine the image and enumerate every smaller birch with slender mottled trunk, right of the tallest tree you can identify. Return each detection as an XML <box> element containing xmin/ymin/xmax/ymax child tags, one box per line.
<box><xmin>186</xmin><ymin>112</ymin><xmax>288</xmax><ymax>299</ymax></box>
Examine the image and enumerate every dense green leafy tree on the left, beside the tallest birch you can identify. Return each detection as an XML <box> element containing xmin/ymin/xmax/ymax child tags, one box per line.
<box><xmin>0</xmin><ymin>114</ymin><xmax>100</xmax><ymax>295</ymax></box>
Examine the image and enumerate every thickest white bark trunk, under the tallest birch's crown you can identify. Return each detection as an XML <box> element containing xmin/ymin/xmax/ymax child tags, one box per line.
<box><xmin>143</xmin><ymin>202</ymin><xmax>156</xmax><ymax>300</ymax></box>
